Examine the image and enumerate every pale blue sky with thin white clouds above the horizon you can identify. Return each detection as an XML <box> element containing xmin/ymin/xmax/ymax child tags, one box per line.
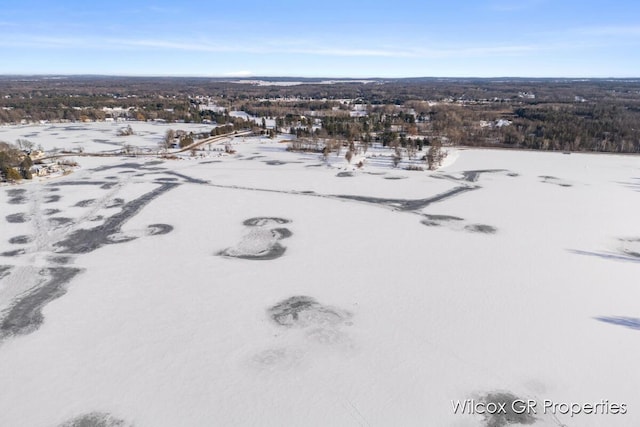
<box><xmin>0</xmin><ymin>0</ymin><xmax>640</xmax><ymax>77</ymax></box>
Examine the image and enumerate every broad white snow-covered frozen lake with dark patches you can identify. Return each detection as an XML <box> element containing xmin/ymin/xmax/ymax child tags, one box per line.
<box><xmin>0</xmin><ymin>124</ymin><xmax>640</xmax><ymax>427</ymax></box>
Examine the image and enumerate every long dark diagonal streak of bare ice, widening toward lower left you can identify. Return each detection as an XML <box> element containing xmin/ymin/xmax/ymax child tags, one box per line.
<box><xmin>55</xmin><ymin>183</ymin><xmax>179</xmax><ymax>254</ymax></box>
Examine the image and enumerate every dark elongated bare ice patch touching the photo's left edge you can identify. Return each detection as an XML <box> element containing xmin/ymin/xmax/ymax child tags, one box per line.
<box><xmin>0</xmin><ymin>267</ymin><xmax>81</xmax><ymax>339</ymax></box>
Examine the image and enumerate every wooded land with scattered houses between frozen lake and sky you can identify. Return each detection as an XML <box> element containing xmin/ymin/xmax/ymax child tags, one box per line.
<box><xmin>0</xmin><ymin>76</ymin><xmax>640</xmax><ymax>180</ymax></box>
